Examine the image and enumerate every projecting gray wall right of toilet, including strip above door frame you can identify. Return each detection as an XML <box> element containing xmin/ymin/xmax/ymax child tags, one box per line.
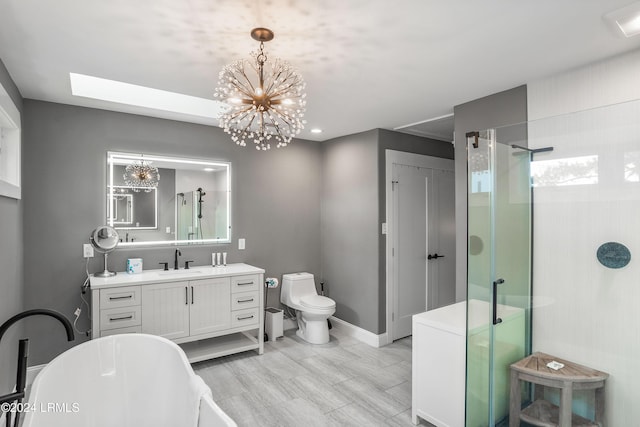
<box><xmin>321</xmin><ymin>129</ymin><xmax>453</xmax><ymax>334</ymax></box>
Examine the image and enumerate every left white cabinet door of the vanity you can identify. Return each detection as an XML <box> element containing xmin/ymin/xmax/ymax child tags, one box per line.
<box><xmin>141</xmin><ymin>282</ymin><xmax>191</xmax><ymax>340</ymax></box>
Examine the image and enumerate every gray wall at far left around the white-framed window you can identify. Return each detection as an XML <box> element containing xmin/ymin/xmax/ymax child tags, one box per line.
<box><xmin>0</xmin><ymin>60</ymin><xmax>24</xmax><ymax>394</ymax></box>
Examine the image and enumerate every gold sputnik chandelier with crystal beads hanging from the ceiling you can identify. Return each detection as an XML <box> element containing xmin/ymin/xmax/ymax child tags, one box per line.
<box><xmin>214</xmin><ymin>28</ymin><xmax>306</xmax><ymax>150</ymax></box>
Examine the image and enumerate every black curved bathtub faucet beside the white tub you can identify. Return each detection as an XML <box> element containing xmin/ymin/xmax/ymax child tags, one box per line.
<box><xmin>0</xmin><ymin>308</ymin><xmax>75</xmax><ymax>426</ymax></box>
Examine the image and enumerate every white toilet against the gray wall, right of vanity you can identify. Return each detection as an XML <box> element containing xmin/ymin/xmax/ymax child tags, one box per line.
<box><xmin>280</xmin><ymin>273</ymin><xmax>336</xmax><ymax>344</ymax></box>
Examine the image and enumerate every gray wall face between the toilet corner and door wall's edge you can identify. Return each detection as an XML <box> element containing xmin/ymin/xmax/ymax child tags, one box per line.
<box><xmin>321</xmin><ymin>130</ymin><xmax>384</xmax><ymax>333</ymax></box>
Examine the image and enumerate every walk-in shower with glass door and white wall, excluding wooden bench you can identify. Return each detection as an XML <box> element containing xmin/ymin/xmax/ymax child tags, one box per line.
<box><xmin>466</xmin><ymin>101</ymin><xmax>640</xmax><ymax>427</ymax></box>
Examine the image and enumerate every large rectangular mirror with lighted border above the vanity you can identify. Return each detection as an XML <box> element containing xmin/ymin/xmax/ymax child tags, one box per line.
<box><xmin>106</xmin><ymin>152</ymin><xmax>231</xmax><ymax>246</ymax></box>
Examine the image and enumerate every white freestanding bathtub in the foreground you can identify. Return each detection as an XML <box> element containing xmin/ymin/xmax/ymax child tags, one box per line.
<box><xmin>22</xmin><ymin>334</ymin><xmax>236</xmax><ymax>427</ymax></box>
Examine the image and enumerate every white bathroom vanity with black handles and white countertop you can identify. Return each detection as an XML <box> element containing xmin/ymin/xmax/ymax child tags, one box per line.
<box><xmin>90</xmin><ymin>264</ymin><xmax>264</xmax><ymax>363</ymax></box>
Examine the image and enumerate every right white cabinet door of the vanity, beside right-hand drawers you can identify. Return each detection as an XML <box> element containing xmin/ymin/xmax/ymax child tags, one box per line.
<box><xmin>189</xmin><ymin>277</ymin><xmax>231</xmax><ymax>335</ymax></box>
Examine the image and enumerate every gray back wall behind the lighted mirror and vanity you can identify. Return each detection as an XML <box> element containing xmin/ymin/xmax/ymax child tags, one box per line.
<box><xmin>23</xmin><ymin>100</ymin><xmax>321</xmax><ymax>365</ymax></box>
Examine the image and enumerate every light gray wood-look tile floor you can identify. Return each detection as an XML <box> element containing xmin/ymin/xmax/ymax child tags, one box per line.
<box><xmin>193</xmin><ymin>328</ymin><xmax>431</xmax><ymax>427</ymax></box>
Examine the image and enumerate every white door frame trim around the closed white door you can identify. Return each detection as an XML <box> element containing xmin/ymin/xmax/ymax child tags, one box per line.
<box><xmin>383</xmin><ymin>149</ymin><xmax>455</xmax><ymax>343</ymax></box>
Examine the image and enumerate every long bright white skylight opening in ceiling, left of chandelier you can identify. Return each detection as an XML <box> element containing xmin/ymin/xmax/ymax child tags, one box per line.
<box><xmin>69</xmin><ymin>73</ymin><xmax>226</xmax><ymax>118</ymax></box>
